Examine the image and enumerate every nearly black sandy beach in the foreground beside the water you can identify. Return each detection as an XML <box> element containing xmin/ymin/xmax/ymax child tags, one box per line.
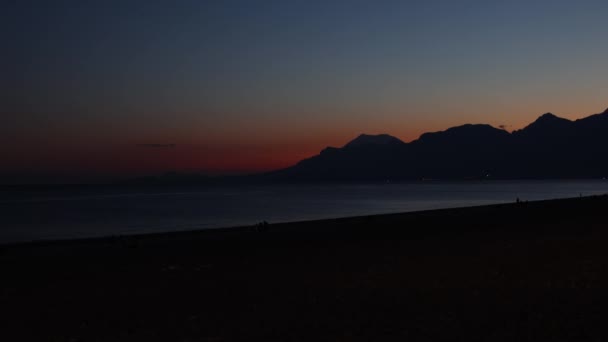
<box><xmin>0</xmin><ymin>196</ymin><xmax>608</xmax><ymax>341</ymax></box>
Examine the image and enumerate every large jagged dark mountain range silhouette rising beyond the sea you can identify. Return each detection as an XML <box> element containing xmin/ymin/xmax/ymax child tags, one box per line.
<box><xmin>262</xmin><ymin>109</ymin><xmax>608</xmax><ymax>181</ymax></box>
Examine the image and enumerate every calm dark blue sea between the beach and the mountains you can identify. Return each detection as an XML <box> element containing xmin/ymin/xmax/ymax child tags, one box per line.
<box><xmin>0</xmin><ymin>180</ymin><xmax>608</xmax><ymax>243</ymax></box>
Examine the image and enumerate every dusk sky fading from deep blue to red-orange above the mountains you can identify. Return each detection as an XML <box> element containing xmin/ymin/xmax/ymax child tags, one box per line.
<box><xmin>0</xmin><ymin>0</ymin><xmax>608</xmax><ymax>183</ymax></box>
